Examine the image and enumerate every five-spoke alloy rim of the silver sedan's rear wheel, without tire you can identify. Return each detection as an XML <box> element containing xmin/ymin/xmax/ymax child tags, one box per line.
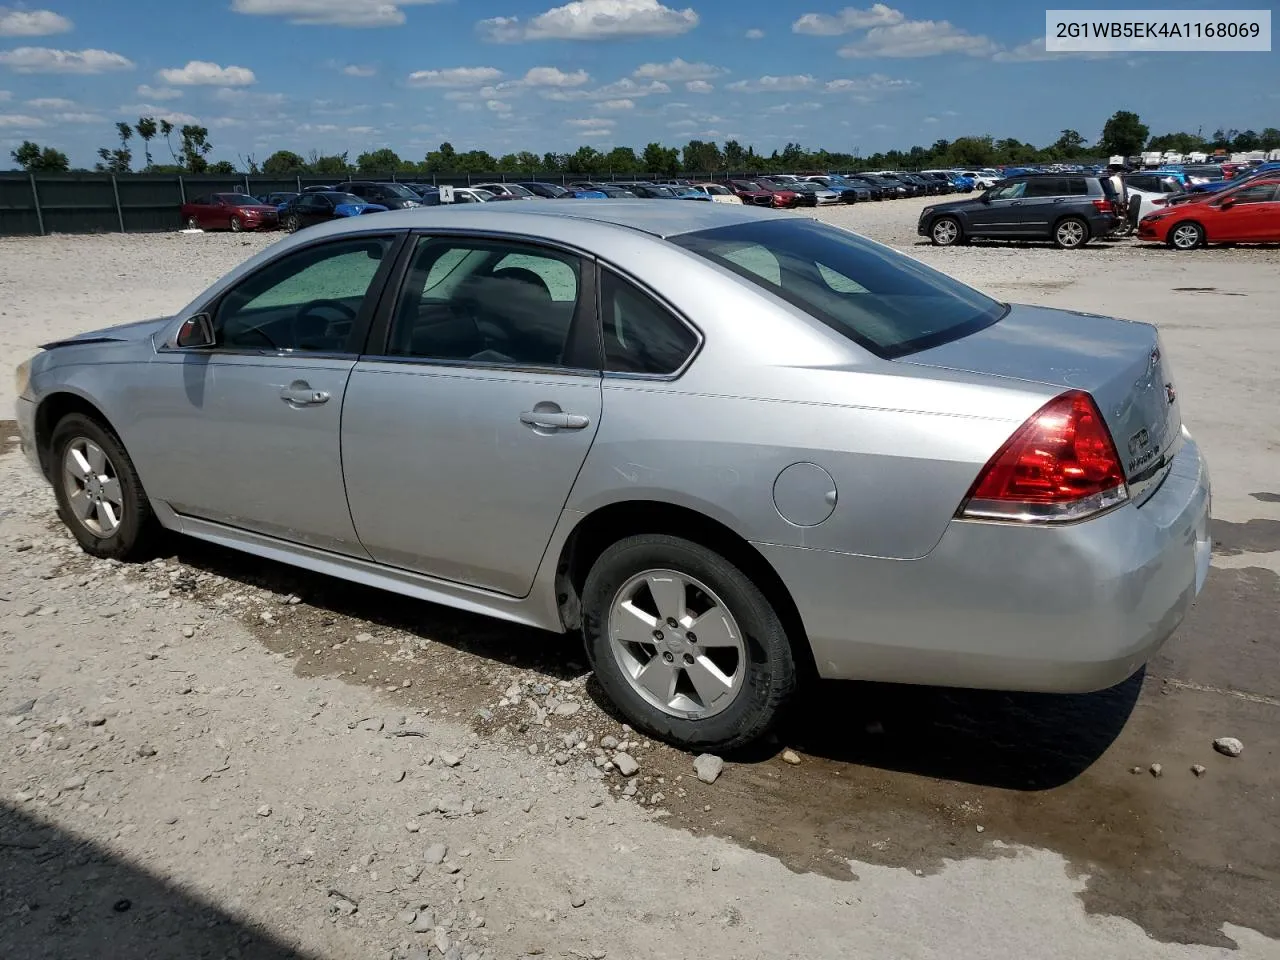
<box><xmin>608</xmin><ymin>570</ymin><xmax>748</xmax><ymax>719</ymax></box>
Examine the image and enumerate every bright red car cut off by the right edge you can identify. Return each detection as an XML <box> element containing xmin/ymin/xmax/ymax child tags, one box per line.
<box><xmin>1138</xmin><ymin>177</ymin><xmax>1280</xmax><ymax>250</ymax></box>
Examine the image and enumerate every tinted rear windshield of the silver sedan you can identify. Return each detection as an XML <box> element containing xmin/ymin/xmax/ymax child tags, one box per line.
<box><xmin>671</xmin><ymin>218</ymin><xmax>1007</xmax><ymax>360</ymax></box>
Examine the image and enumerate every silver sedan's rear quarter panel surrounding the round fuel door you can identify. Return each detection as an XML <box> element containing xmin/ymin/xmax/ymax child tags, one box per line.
<box><xmin>567</xmin><ymin>240</ymin><xmax>1055</xmax><ymax>559</ymax></box>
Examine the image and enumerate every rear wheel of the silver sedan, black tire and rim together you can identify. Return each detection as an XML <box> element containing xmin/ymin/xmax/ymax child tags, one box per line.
<box><xmin>582</xmin><ymin>534</ymin><xmax>796</xmax><ymax>750</ymax></box>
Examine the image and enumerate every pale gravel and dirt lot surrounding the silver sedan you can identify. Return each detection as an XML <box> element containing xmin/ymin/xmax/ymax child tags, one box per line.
<box><xmin>0</xmin><ymin>201</ymin><xmax>1280</xmax><ymax>960</ymax></box>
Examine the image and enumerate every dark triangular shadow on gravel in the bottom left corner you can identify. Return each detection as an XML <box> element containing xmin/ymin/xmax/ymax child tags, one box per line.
<box><xmin>0</xmin><ymin>803</ymin><xmax>316</xmax><ymax>960</ymax></box>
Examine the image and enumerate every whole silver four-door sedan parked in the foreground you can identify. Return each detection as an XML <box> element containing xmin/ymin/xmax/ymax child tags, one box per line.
<box><xmin>18</xmin><ymin>201</ymin><xmax>1210</xmax><ymax>749</ymax></box>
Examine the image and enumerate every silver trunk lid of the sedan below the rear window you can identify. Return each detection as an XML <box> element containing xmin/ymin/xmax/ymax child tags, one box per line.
<box><xmin>899</xmin><ymin>305</ymin><xmax>1183</xmax><ymax>503</ymax></box>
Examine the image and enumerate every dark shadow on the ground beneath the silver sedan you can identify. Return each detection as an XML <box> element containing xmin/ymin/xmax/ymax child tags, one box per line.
<box><xmin>152</xmin><ymin>538</ymin><xmax>1142</xmax><ymax>790</ymax></box>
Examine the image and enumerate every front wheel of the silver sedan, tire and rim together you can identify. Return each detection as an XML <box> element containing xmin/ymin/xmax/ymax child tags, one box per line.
<box><xmin>50</xmin><ymin>413</ymin><xmax>159</xmax><ymax>561</ymax></box>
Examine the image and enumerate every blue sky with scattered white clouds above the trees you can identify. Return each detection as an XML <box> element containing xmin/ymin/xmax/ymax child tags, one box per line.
<box><xmin>0</xmin><ymin>0</ymin><xmax>1280</xmax><ymax>166</ymax></box>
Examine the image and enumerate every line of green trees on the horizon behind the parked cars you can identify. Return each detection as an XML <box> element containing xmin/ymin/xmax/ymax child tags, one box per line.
<box><xmin>10</xmin><ymin>110</ymin><xmax>1280</xmax><ymax>177</ymax></box>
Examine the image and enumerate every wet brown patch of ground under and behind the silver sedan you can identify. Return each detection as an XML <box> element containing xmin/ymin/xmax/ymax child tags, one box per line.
<box><xmin>27</xmin><ymin>506</ymin><xmax>1280</xmax><ymax>946</ymax></box>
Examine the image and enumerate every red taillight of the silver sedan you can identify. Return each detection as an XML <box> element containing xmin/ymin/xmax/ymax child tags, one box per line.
<box><xmin>957</xmin><ymin>390</ymin><xmax>1129</xmax><ymax>522</ymax></box>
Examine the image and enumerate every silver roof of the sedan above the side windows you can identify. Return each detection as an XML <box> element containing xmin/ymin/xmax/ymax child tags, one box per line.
<box><xmin>316</xmin><ymin>200</ymin><xmax>780</xmax><ymax>237</ymax></box>
